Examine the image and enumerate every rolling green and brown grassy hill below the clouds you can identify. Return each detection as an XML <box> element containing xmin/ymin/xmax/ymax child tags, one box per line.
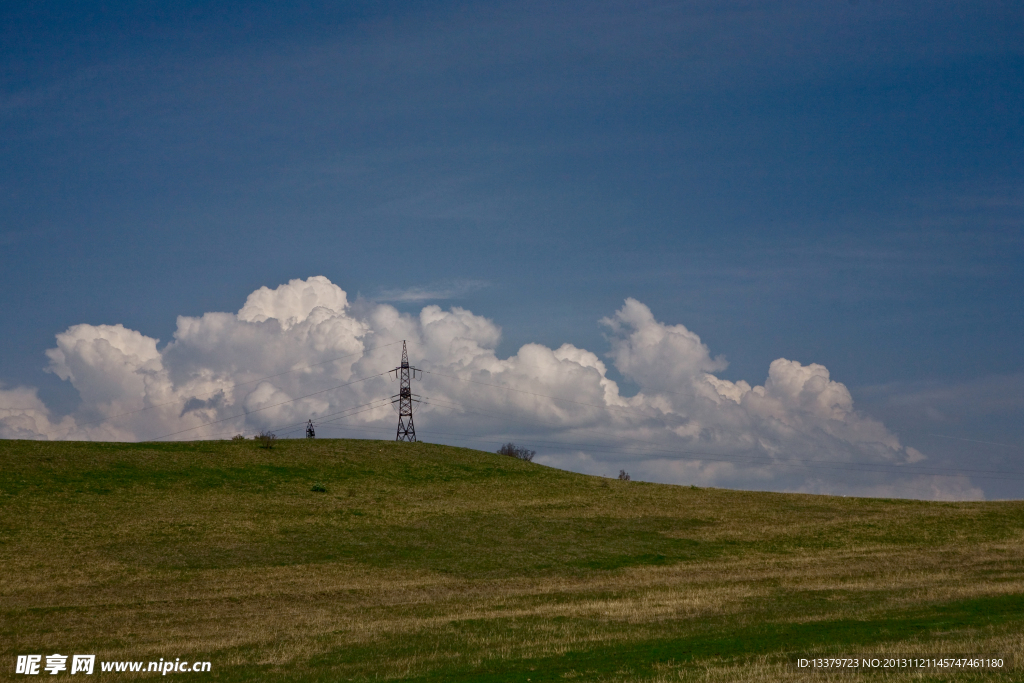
<box><xmin>0</xmin><ymin>439</ymin><xmax>1024</xmax><ymax>683</ymax></box>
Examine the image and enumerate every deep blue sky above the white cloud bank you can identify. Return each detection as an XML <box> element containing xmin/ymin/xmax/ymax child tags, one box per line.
<box><xmin>0</xmin><ymin>1</ymin><xmax>1024</xmax><ymax>498</ymax></box>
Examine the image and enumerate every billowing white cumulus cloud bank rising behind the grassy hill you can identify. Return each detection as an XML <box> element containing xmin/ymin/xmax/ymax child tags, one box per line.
<box><xmin>0</xmin><ymin>276</ymin><xmax>982</xmax><ymax>499</ymax></box>
